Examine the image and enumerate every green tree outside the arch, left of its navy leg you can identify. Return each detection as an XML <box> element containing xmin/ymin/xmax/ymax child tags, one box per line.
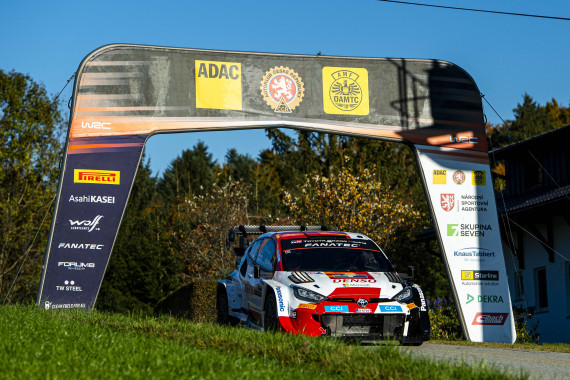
<box><xmin>0</xmin><ymin>70</ymin><xmax>62</xmax><ymax>302</ymax></box>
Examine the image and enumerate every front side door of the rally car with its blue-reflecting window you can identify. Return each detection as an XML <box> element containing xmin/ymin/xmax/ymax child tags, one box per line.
<box><xmin>246</xmin><ymin>238</ymin><xmax>276</xmax><ymax>317</ymax></box>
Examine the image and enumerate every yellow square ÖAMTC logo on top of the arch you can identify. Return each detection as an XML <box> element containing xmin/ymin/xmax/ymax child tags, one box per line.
<box><xmin>323</xmin><ymin>67</ymin><xmax>370</xmax><ymax>115</ymax></box>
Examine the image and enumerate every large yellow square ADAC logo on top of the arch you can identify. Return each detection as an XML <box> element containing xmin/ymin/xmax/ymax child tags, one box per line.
<box><xmin>195</xmin><ymin>61</ymin><xmax>242</xmax><ymax>111</ymax></box>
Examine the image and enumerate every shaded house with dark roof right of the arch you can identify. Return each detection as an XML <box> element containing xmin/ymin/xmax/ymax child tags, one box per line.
<box><xmin>489</xmin><ymin>125</ymin><xmax>570</xmax><ymax>343</ymax></box>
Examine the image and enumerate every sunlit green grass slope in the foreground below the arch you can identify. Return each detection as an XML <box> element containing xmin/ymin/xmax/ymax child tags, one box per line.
<box><xmin>0</xmin><ymin>306</ymin><xmax>524</xmax><ymax>380</ymax></box>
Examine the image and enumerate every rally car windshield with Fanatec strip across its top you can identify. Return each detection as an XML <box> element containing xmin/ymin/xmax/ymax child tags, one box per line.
<box><xmin>281</xmin><ymin>239</ymin><xmax>393</xmax><ymax>272</ymax></box>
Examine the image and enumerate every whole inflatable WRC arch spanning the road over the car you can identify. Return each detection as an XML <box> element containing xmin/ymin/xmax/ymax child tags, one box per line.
<box><xmin>37</xmin><ymin>45</ymin><xmax>516</xmax><ymax>343</ymax></box>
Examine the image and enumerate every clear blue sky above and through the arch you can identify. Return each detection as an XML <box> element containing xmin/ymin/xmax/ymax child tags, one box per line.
<box><xmin>0</xmin><ymin>0</ymin><xmax>570</xmax><ymax>174</ymax></box>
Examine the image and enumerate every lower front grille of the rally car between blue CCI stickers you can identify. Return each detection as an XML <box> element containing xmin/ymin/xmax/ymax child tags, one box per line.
<box><xmin>321</xmin><ymin>314</ymin><xmax>404</xmax><ymax>339</ymax></box>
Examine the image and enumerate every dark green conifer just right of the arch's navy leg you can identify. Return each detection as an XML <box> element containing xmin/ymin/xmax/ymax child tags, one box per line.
<box><xmin>96</xmin><ymin>158</ymin><xmax>184</xmax><ymax>314</ymax></box>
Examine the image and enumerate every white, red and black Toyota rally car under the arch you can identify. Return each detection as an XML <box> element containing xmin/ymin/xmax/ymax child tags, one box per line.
<box><xmin>217</xmin><ymin>226</ymin><xmax>431</xmax><ymax>345</ymax></box>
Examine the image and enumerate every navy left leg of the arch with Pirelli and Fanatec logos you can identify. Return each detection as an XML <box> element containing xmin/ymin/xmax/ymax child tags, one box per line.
<box><xmin>39</xmin><ymin>136</ymin><xmax>144</xmax><ymax>310</ymax></box>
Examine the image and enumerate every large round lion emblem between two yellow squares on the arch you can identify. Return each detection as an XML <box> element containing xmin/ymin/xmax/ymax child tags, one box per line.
<box><xmin>260</xmin><ymin>66</ymin><xmax>305</xmax><ymax>113</ymax></box>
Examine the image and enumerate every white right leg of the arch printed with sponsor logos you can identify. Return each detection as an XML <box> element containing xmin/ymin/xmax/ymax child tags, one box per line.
<box><xmin>412</xmin><ymin>147</ymin><xmax>516</xmax><ymax>343</ymax></box>
